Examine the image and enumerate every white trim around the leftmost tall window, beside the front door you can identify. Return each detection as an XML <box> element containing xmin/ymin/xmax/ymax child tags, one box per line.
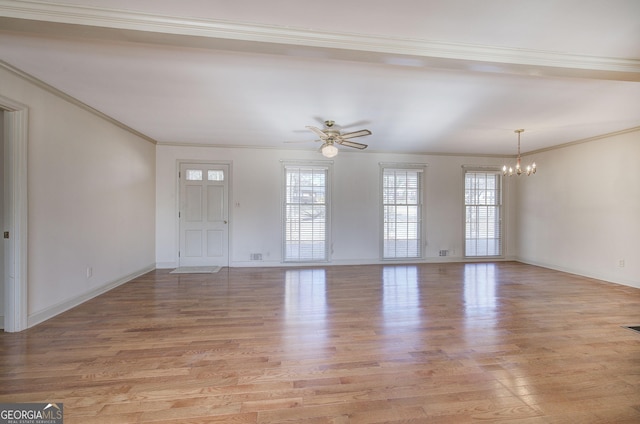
<box><xmin>280</xmin><ymin>160</ymin><xmax>333</xmax><ymax>265</ymax></box>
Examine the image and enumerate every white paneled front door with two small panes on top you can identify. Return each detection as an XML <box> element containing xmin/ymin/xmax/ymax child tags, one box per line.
<box><xmin>178</xmin><ymin>163</ymin><xmax>229</xmax><ymax>266</ymax></box>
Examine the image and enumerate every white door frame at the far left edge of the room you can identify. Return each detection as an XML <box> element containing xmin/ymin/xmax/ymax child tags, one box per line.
<box><xmin>0</xmin><ymin>96</ymin><xmax>29</xmax><ymax>332</ymax></box>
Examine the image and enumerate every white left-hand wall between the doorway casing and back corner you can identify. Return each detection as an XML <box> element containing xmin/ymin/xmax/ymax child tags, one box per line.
<box><xmin>0</xmin><ymin>69</ymin><xmax>155</xmax><ymax>326</ymax></box>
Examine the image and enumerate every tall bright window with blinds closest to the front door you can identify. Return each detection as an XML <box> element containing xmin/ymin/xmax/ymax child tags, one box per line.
<box><xmin>284</xmin><ymin>165</ymin><xmax>329</xmax><ymax>262</ymax></box>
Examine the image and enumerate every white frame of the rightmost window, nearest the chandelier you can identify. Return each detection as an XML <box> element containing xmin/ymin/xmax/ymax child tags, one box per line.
<box><xmin>462</xmin><ymin>165</ymin><xmax>505</xmax><ymax>260</ymax></box>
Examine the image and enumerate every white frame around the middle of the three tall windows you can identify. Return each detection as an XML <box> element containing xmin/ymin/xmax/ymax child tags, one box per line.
<box><xmin>379</xmin><ymin>162</ymin><xmax>427</xmax><ymax>261</ymax></box>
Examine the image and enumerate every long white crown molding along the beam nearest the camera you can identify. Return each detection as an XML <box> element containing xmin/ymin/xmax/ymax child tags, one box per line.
<box><xmin>0</xmin><ymin>0</ymin><xmax>640</xmax><ymax>81</ymax></box>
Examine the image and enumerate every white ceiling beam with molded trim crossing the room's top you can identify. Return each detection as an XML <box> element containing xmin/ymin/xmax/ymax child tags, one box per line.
<box><xmin>0</xmin><ymin>0</ymin><xmax>640</xmax><ymax>81</ymax></box>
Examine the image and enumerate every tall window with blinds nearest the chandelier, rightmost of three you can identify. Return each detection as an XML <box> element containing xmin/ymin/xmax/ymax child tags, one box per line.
<box><xmin>464</xmin><ymin>169</ymin><xmax>502</xmax><ymax>257</ymax></box>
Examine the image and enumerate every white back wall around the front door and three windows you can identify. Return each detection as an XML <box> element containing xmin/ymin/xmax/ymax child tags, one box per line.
<box><xmin>156</xmin><ymin>145</ymin><xmax>515</xmax><ymax>268</ymax></box>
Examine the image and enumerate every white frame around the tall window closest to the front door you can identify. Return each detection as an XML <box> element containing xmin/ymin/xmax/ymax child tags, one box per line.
<box><xmin>281</xmin><ymin>161</ymin><xmax>333</xmax><ymax>264</ymax></box>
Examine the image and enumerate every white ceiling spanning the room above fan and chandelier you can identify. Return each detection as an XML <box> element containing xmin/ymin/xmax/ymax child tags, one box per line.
<box><xmin>0</xmin><ymin>0</ymin><xmax>640</xmax><ymax>155</ymax></box>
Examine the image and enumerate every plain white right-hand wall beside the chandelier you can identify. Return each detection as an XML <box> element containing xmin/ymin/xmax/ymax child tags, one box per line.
<box><xmin>517</xmin><ymin>131</ymin><xmax>640</xmax><ymax>288</ymax></box>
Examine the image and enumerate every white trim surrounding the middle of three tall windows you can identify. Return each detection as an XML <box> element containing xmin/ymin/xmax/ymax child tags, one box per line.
<box><xmin>378</xmin><ymin>162</ymin><xmax>428</xmax><ymax>262</ymax></box>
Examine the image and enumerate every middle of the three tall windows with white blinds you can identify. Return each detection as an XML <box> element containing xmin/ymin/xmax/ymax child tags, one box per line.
<box><xmin>382</xmin><ymin>167</ymin><xmax>422</xmax><ymax>259</ymax></box>
